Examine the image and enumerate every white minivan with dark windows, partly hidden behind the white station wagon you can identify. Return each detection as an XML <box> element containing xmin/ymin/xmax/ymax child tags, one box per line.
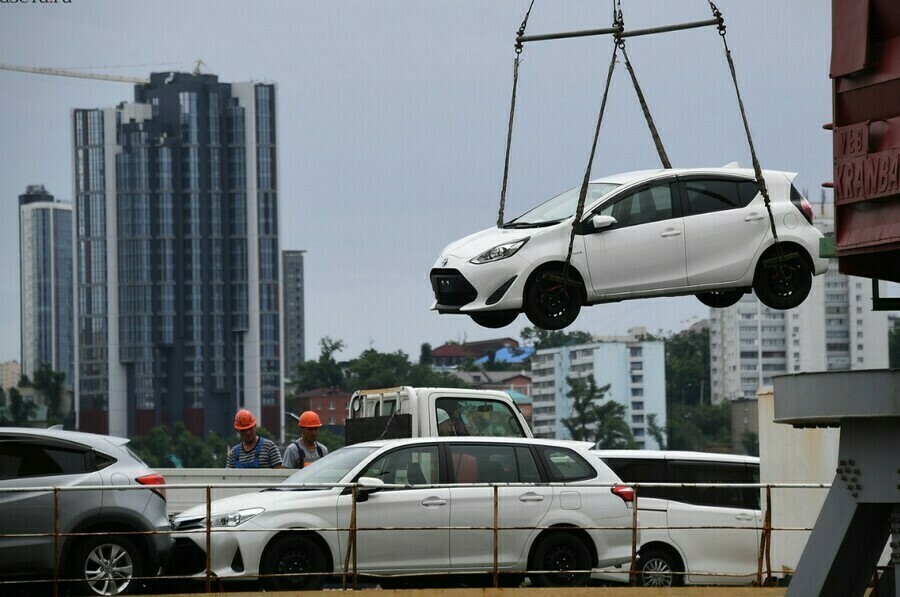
<box><xmin>591</xmin><ymin>450</ymin><xmax>762</xmax><ymax>587</ymax></box>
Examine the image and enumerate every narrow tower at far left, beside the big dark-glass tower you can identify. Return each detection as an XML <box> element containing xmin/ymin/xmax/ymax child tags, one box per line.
<box><xmin>19</xmin><ymin>185</ymin><xmax>75</xmax><ymax>388</ymax></box>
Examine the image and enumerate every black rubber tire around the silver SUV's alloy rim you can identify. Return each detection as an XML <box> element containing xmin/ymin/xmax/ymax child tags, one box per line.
<box><xmin>71</xmin><ymin>535</ymin><xmax>148</xmax><ymax>596</ymax></box>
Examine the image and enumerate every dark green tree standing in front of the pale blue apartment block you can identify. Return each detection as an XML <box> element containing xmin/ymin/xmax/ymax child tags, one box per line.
<box><xmin>562</xmin><ymin>375</ymin><xmax>635</xmax><ymax>449</ymax></box>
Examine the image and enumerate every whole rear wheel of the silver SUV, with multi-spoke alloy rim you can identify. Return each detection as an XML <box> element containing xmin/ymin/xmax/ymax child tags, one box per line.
<box><xmin>74</xmin><ymin>535</ymin><xmax>146</xmax><ymax>595</ymax></box>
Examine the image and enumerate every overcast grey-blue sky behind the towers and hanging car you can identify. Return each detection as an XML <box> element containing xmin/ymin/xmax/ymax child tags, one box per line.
<box><xmin>0</xmin><ymin>0</ymin><xmax>832</xmax><ymax>361</ymax></box>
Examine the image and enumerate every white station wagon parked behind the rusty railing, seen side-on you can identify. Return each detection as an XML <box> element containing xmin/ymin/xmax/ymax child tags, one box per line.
<box><xmin>166</xmin><ymin>437</ymin><xmax>633</xmax><ymax>590</ymax></box>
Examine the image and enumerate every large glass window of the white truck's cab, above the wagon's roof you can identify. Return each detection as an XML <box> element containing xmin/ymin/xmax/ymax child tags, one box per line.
<box><xmin>435</xmin><ymin>398</ymin><xmax>527</xmax><ymax>437</ymax></box>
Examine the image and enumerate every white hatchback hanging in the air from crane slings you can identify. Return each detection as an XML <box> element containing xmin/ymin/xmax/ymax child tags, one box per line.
<box><xmin>430</xmin><ymin>165</ymin><xmax>828</xmax><ymax>330</ymax></box>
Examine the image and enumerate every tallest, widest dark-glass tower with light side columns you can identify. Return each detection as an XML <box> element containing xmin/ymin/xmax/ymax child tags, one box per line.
<box><xmin>72</xmin><ymin>72</ymin><xmax>284</xmax><ymax>435</ymax></box>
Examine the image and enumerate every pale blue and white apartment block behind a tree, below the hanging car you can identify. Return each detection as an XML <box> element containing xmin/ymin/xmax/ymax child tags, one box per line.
<box><xmin>531</xmin><ymin>328</ymin><xmax>666</xmax><ymax>449</ymax></box>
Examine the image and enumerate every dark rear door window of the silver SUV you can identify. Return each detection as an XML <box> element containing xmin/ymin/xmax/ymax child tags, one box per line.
<box><xmin>0</xmin><ymin>441</ymin><xmax>88</xmax><ymax>479</ymax></box>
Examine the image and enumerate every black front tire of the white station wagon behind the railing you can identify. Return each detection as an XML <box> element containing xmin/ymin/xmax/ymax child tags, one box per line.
<box><xmin>261</xmin><ymin>535</ymin><xmax>328</xmax><ymax>591</ymax></box>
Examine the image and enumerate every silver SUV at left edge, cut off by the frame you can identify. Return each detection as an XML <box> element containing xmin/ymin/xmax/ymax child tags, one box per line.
<box><xmin>0</xmin><ymin>428</ymin><xmax>173</xmax><ymax>595</ymax></box>
